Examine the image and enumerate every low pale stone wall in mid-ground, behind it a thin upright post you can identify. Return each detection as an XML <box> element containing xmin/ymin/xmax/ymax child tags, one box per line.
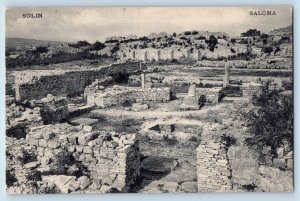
<box><xmin>86</xmin><ymin>87</ymin><xmax>171</xmax><ymax>108</ymax></box>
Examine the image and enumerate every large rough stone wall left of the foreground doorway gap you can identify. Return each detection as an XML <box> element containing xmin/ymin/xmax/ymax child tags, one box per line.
<box><xmin>26</xmin><ymin>124</ymin><xmax>140</xmax><ymax>193</ymax></box>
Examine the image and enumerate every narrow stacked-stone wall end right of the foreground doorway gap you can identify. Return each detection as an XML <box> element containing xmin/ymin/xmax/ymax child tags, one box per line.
<box><xmin>197</xmin><ymin>139</ymin><xmax>232</xmax><ymax>192</ymax></box>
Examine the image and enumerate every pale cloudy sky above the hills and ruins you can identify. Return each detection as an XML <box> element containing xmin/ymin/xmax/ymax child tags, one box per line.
<box><xmin>5</xmin><ymin>6</ymin><xmax>292</xmax><ymax>42</ymax></box>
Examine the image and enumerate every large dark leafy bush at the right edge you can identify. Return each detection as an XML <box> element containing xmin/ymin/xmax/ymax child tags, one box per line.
<box><xmin>245</xmin><ymin>80</ymin><xmax>294</xmax><ymax>155</ymax></box>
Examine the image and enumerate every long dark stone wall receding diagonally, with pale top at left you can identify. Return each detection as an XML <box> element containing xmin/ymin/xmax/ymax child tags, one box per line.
<box><xmin>14</xmin><ymin>62</ymin><xmax>146</xmax><ymax>100</ymax></box>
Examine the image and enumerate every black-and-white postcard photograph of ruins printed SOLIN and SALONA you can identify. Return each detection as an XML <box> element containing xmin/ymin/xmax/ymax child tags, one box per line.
<box><xmin>5</xmin><ymin>6</ymin><xmax>294</xmax><ymax>194</ymax></box>
